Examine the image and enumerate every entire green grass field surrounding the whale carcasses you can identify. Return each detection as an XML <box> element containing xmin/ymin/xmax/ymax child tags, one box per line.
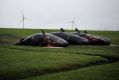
<box><xmin>0</xmin><ymin>29</ymin><xmax>119</xmax><ymax>80</ymax></box>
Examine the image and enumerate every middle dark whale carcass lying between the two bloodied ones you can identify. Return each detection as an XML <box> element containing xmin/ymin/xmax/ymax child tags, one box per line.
<box><xmin>51</xmin><ymin>28</ymin><xmax>88</xmax><ymax>45</ymax></box>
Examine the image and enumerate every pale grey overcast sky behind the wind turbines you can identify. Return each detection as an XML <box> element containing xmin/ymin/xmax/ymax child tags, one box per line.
<box><xmin>0</xmin><ymin>0</ymin><xmax>119</xmax><ymax>31</ymax></box>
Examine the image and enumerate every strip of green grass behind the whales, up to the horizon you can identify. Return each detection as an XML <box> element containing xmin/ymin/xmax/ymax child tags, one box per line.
<box><xmin>0</xmin><ymin>28</ymin><xmax>119</xmax><ymax>44</ymax></box>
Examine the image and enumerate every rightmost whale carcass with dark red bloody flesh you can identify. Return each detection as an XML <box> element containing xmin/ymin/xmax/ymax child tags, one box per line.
<box><xmin>72</xmin><ymin>28</ymin><xmax>110</xmax><ymax>45</ymax></box>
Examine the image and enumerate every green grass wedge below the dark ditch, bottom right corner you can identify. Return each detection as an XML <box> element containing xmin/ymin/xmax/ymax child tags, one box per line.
<box><xmin>23</xmin><ymin>62</ymin><xmax>119</xmax><ymax>80</ymax></box>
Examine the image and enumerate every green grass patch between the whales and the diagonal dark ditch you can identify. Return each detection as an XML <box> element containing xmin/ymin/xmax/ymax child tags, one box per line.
<box><xmin>0</xmin><ymin>48</ymin><xmax>108</xmax><ymax>79</ymax></box>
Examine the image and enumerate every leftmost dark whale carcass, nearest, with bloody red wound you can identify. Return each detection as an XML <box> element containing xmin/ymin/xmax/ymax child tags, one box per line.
<box><xmin>16</xmin><ymin>33</ymin><xmax>68</xmax><ymax>47</ymax></box>
